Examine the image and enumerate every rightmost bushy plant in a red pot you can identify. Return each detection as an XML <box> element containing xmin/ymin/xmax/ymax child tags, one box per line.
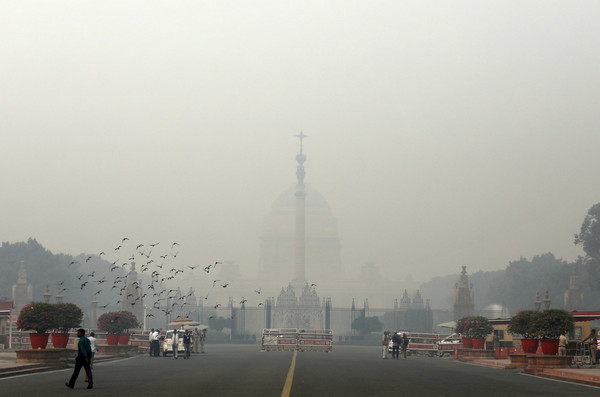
<box><xmin>533</xmin><ymin>309</ymin><xmax>575</xmax><ymax>355</ymax></box>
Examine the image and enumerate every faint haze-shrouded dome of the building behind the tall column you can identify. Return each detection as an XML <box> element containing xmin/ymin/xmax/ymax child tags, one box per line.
<box><xmin>259</xmin><ymin>184</ymin><xmax>342</xmax><ymax>285</ymax></box>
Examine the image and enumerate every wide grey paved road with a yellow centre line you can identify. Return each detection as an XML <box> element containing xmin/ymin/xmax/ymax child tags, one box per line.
<box><xmin>0</xmin><ymin>345</ymin><xmax>600</xmax><ymax>397</ymax></box>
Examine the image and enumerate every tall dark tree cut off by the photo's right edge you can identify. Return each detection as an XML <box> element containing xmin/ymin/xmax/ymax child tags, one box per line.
<box><xmin>575</xmin><ymin>203</ymin><xmax>600</xmax><ymax>287</ymax></box>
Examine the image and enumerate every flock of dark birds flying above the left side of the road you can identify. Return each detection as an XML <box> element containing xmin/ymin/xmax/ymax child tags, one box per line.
<box><xmin>58</xmin><ymin>237</ymin><xmax>272</xmax><ymax>320</ymax></box>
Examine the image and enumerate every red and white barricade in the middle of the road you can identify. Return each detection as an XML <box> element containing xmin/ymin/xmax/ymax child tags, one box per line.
<box><xmin>261</xmin><ymin>328</ymin><xmax>333</xmax><ymax>352</ymax></box>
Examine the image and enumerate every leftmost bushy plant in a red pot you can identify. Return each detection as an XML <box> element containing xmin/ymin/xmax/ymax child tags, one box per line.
<box><xmin>17</xmin><ymin>302</ymin><xmax>56</xmax><ymax>349</ymax></box>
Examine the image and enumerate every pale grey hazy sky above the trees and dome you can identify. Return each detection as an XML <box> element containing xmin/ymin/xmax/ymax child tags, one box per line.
<box><xmin>0</xmin><ymin>0</ymin><xmax>600</xmax><ymax>281</ymax></box>
